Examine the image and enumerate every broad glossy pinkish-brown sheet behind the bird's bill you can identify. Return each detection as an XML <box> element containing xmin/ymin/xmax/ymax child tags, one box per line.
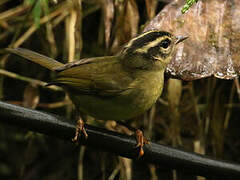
<box><xmin>144</xmin><ymin>0</ymin><xmax>240</xmax><ymax>80</ymax></box>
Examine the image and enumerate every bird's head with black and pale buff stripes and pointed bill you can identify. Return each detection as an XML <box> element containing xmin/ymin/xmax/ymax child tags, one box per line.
<box><xmin>120</xmin><ymin>30</ymin><xmax>187</xmax><ymax>69</ymax></box>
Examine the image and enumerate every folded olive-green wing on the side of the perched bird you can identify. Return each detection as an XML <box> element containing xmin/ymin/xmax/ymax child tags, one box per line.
<box><xmin>51</xmin><ymin>56</ymin><xmax>132</xmax><ymax>96</ymax></box>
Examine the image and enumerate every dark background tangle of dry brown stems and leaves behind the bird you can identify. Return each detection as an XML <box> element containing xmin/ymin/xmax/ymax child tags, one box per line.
<box><xmin>0</xmin><ymin>0</ymin><xmax>240</xmax><ymax>180</ymax></box>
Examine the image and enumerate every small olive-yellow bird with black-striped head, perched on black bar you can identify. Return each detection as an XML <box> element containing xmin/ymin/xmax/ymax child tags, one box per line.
<box><xmin>6</xmin><ymin>30</ymin><xmax>187</xmax><ymax>156</ymax></box>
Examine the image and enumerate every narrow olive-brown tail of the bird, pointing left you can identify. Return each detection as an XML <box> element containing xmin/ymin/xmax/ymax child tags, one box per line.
<box><xmin>6</xmin><ymin>48</ymin><xmax>64</xmax><ymax>71</ymax></box>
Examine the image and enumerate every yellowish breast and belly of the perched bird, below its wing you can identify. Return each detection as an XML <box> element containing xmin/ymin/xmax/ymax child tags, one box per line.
<box><xmin>70</xmin><ymin>71</ymin><xmax>164</xmax><ymax>120</ymax></box>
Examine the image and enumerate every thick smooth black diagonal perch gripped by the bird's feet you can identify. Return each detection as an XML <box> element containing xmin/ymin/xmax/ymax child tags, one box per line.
<box><xmin>0</xmin><ymin>101</ymin><xmax>240</xmax><ymax>179</ymax></box>
